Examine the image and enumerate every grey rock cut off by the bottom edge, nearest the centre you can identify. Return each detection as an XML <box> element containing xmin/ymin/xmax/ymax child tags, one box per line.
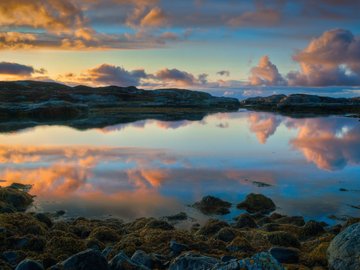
<box><xmin>169</xmin><ymin>252</ymin><xmax>219</xmax><ymax>270</ymax></box>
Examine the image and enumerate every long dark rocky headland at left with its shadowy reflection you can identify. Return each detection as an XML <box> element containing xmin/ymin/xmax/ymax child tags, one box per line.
<box><xmin>0</xmin><ymin>81</ymin><xmax>240</xmax><ymax>131</ymax></box>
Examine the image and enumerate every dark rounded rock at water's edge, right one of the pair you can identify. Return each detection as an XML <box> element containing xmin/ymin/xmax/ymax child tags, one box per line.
<box><xmin>237</xmin><ymin>193</ymin><xmax>276</xmax><ymax>214</ymax></box>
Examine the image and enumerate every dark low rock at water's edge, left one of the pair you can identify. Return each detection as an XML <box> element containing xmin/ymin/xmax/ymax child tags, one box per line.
<box><xmin>193</xmin><ymin>196</ymin><xmax>231</xmax><ymax>215</ymax></box>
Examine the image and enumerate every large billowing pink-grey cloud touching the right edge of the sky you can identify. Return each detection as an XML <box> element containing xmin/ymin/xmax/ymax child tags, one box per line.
<box><xmin>287</xmin><ymin>29</ymin><xmax>360</xmax><ymax>86</ymax></box>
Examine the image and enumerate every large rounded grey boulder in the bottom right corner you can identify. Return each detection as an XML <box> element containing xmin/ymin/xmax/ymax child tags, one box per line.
<box><xmin>327</xmin><ymin>223</ymin><xmax>360</xmax><ymax>270</ymax></box>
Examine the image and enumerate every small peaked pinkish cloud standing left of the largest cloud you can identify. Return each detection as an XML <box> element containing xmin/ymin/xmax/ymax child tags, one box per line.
<box><xmin>249</xmin><ymin>55</ymin><xmax>286</xmax><ymax>85</ymax></box>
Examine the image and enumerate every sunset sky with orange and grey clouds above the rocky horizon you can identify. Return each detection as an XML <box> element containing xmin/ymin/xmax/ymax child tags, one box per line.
<box><xmin>0</xmin><ymin>0</ymin><xmax>360</xmax><ymax>95</ymax></box>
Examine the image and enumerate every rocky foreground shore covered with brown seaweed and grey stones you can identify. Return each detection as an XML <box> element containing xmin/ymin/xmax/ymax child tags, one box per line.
<box><xmin>0</xmin><ymin>184</ymin><xmax>360</xmax><ymax>270</ymax></box>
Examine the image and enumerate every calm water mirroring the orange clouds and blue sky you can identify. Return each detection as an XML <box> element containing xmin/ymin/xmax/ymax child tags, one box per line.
<box><xmin>0</xmin><ymin>111</ymin><xmax>360</xmax><ymax>225</ymax></box>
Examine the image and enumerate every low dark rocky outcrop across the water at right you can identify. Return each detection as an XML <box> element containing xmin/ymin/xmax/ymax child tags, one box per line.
<box><xmin>240</xmin><ymin>94</ymin><xmax>360</xmax><ymax>114</ymax></box>
